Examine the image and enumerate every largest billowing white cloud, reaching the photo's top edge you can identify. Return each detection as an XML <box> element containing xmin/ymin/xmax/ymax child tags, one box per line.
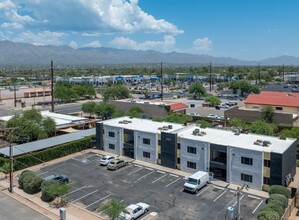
<box><xmin>7</xmin><ymin>0</ymin><xmax>183</xmax><ymax>35</ymax></box>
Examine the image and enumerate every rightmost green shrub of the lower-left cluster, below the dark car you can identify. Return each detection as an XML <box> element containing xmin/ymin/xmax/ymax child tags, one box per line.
<box><xmin>41</xmin><ymin>180</ymin><xmax>71</xmax><ymax>202</ymax></box>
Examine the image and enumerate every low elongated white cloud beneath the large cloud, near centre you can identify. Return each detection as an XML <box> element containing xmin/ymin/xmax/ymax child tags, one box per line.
<box><xmin>110</xmin><ymin>35</ymin><xmax>176</xmax><ymax>52</ymax></box>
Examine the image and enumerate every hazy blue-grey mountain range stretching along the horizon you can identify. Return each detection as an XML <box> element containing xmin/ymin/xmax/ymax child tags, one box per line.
<box><xmin>0</xmin><ymin>40</ymin><xmax>299</xmax><ymax>66</ymax></box>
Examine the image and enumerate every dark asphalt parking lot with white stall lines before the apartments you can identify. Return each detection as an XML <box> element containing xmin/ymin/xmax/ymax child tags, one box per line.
<box><xmin>37</xmin><ymin>153</ymin><xmax>265</xmax><ymax>220</ymax></box>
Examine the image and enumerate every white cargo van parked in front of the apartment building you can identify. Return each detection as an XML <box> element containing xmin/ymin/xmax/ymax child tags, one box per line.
<box><xmin>184</xmin><ymin>171</ymin><xmax>210</xmax><ymax>193</ymax></box>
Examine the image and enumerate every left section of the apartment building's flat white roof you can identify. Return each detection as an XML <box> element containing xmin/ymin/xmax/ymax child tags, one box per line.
<box><xmin>103</xmin><ymin>116</ymin><xmax>185</xmax><ymax>133</ymax></box>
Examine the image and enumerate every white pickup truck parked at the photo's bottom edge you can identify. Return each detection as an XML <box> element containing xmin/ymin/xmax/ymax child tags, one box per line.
<box><xmin>117</xmin><ymin>202</ymin><xmax>149</xmax><ymax>220</ymax></box>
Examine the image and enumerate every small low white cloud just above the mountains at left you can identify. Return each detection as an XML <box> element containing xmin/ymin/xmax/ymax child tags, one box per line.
<box><xmin>14</xmin><ymin>31</ymin><xmax>66</xmax><ymax>45</ymax></box>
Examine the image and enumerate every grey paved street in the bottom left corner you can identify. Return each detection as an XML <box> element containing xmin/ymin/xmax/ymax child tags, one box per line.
<box><xmin>0</xmin><ymin>192</ymin><xmax>49</xmax><ymax>220</ymax></box>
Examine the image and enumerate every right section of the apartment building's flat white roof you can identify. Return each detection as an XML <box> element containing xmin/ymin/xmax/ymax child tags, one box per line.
<box><xmin>178</xmin><ymin>125</ymin><xmax>296</xmax><ymax>154</ymax></box>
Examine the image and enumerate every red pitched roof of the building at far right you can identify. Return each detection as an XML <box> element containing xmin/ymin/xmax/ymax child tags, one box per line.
<box><xmin>245</xmin><ymin>92</ymin><xmax>299</xmax><ymax>108</ymax></box>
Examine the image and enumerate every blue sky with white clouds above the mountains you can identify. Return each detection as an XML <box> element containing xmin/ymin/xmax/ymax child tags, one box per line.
<box><xmin>0</xmin><ymin>0</ymin><xmax>299</xmax><ymax>60</ymax></box>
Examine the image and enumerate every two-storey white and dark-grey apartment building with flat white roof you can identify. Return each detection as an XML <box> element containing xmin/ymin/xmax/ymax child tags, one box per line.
<box><xmin>96</xmin><ymin>117</ymin><xmax>297</xmax><ymax>190</ymax></box>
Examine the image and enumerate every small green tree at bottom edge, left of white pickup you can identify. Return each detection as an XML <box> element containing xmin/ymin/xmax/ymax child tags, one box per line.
<box><xmin>99</xmin><ymin>199</ymin><xmax>125</xmax><ymax>219</ymax></box>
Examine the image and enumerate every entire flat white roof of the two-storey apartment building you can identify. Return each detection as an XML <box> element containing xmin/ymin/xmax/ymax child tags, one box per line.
<box><xmin>99</xmin><ymin>116</ymin><xmax>296</xmax><ymax>154</ymax></box>
